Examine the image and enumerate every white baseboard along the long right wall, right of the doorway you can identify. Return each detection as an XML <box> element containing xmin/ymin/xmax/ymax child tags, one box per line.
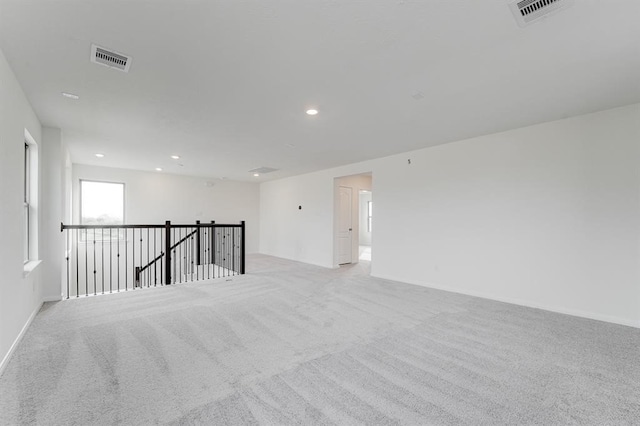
<box><xmin>371</xmin><ymin>274</ymin><xmax>640</xmax><ymax>328</ymax></box>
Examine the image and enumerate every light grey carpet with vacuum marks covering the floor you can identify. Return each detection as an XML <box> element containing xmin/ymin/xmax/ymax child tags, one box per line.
<box><xmin>0</xmin><ymin>256</ymin><xmax>640</xmax><ymax>425</ymax></box>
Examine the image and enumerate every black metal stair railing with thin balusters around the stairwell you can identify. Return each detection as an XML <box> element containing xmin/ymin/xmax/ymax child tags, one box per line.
<box><xmin>61</xmin><ymin>221</ymin><xmax>245</xmax><ymax>299</ymax></box>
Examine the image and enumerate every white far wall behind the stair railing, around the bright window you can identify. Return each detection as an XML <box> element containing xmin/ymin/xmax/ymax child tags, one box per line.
<box><xmin>72</xmin><ymin>164</ymin><xmax>260</xmax><ymax>253</ymax></box>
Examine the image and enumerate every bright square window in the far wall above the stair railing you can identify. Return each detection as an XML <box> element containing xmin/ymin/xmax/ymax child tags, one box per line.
<box><xmin>80</xmin><ymin>180</ymin><xmax>124</xmax><ymax>240</ymax></box>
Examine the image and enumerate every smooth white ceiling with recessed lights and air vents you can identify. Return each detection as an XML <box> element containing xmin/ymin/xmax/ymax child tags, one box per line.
<box><xmin>0</xmin><ymin>0</ymin><xmax>640</xmax><ymax>181</ymax></box>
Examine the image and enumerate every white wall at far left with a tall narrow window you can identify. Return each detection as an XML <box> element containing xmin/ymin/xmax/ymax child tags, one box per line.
<box><xmin>0</xmin><ymin>51</ymin><xmax>43</xmax><ymax>367</ymax></box>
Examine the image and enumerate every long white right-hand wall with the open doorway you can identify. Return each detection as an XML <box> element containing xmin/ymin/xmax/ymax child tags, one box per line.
<box><xmin>260</xmin><ymin>105</ymin><xmax>640</xmax><ymax>326</ymax></box>
